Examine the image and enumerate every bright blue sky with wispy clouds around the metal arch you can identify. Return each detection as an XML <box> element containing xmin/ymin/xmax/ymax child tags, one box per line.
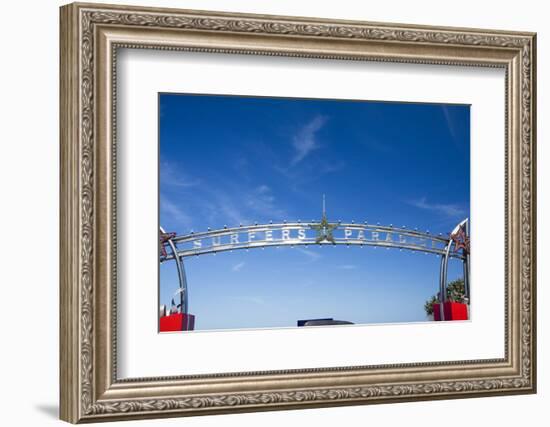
<box><xmin>159</xmin><ymin>94</ymin><xmax>475</xmax><ymax>330</ymax></box>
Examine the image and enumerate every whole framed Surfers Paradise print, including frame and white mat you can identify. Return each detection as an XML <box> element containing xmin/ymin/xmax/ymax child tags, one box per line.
<box><xmin>60</xmin><ymin>4</ymin><xmax>536</xmax><ymax>423</ymax></box>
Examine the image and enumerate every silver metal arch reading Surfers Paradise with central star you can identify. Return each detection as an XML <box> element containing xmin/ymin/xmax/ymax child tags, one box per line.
<box><xmin>160</xmin><ymin>210</ymin><xmax>470</xmax><ymax>319</ymax></box>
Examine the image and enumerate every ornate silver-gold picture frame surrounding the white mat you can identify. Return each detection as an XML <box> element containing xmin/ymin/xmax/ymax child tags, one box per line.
<box><xmin>60</xmin><ymin>4</ymin><xmax>536</xmax><ymax>423</ymax></box>
